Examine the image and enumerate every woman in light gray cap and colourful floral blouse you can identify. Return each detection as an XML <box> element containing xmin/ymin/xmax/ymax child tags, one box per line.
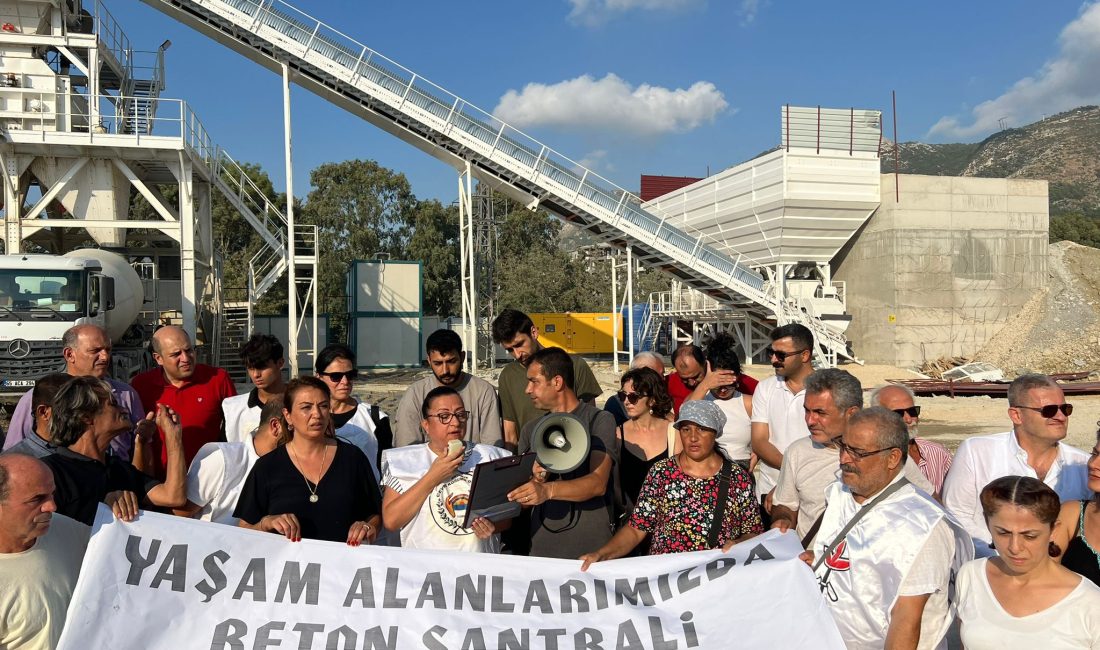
<box><xmin>581</xmin><ymin>400</ymin><xmax>763</xmax><ymax>571</ymax></box>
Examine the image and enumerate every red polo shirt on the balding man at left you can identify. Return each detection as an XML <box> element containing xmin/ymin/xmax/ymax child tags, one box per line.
<box><xmin>130</xmin><ymin>363</ymin><xmax>237</xmax><ymax>467</ymax></box>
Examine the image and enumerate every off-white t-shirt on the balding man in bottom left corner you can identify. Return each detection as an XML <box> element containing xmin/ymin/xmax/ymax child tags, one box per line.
<box><xmin>0</xmin><ymin>513</ymin><xmax>91</xmax><ymax>650</ymax></box>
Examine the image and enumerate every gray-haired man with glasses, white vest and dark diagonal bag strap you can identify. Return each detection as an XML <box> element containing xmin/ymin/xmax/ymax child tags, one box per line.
<box><xmin>803</xmin><ymin>409</ymin><xmax>974</xmax><ymax>650</ymax></box>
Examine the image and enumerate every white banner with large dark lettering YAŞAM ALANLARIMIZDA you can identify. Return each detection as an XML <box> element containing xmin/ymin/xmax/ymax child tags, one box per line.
<box><xmin>59</xmin><ymin>507</ymin><xmax>844</xmax><ymax>650</ymax></box>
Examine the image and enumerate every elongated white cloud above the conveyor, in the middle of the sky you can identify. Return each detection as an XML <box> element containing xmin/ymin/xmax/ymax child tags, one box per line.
<box><xmin>493</xmin><ymin>74</ymin><xmax>729</xmax><ymax>135</ymax></box>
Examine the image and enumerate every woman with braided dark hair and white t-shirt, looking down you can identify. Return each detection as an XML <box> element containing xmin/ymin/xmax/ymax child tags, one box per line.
<box><xmin>955</xmin><ymin>476</ymin><xmax>1100</xmax><ymax>650</ymax></box>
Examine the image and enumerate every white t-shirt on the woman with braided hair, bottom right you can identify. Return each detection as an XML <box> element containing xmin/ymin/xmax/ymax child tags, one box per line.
<box><xmin>955</xmin><ymin>558</ymin><xmax>1100</xmax><ymax>650</ymax></box>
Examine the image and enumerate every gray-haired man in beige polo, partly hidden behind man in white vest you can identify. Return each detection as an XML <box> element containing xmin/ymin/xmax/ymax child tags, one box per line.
<box><xmin>771</xmin><ymin>368</ymin><xmax>932</xmax><ymax>548</ymax></box>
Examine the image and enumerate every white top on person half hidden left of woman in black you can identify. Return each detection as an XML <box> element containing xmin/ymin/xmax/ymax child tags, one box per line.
<box><xmin>187</xmin><ymin>436</ymin><xmax>260</xmax><ymax>526</ymax></box>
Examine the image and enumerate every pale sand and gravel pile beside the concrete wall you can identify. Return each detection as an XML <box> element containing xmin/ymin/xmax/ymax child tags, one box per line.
<box><xmin>975</xmin><ymin>242</ymin><xmax>1100</xmax><ymax>376</ymax></box>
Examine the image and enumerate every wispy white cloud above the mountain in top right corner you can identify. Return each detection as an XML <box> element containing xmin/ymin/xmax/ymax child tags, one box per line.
<box><xmin>928</xmin><ymin>2</ymin><xmax>1100</xmax><ymax>137</ymax></box>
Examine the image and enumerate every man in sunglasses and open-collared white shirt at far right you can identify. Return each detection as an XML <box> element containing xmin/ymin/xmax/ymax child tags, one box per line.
<box><xmin>944</xmin><ymin>374</ymin><xmax>1090</xmax><ymax>558</ymax></box>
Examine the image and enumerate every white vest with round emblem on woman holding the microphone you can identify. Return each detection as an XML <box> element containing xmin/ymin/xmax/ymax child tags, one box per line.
<box><xmin>382</xmin><ymin>443</ymin><xmax>510</xmax><ymax>553</ymax></box>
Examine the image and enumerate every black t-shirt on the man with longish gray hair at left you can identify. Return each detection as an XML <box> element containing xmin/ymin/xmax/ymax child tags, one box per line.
<box><xmin>42</xmin><ymin>447</ymin><xmax>161</xmax><ymax>526</ymax></box>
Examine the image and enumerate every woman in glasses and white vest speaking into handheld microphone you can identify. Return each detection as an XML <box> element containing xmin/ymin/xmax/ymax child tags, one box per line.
<box><xmin>382</xmin><ymin>386</ymin><xmax>510</xmax><ymax>553</ymax></box>
